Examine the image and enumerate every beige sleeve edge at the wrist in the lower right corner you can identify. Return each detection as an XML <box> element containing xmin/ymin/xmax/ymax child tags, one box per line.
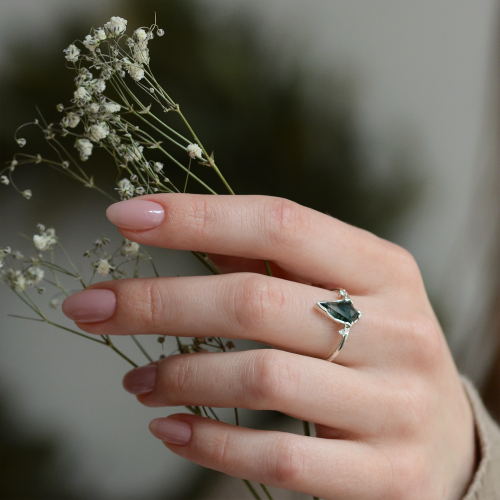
<box><xmin>462</xmin><ymin>378</ymin><xmax>500</xmax><ymax>500</ymax></box>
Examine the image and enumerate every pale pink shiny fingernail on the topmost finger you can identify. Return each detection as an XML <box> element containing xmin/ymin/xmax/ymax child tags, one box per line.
<box><xmin>106</xmin><ymin>200</ymin><xmax>165</xmax><ymax>231</ymax></box>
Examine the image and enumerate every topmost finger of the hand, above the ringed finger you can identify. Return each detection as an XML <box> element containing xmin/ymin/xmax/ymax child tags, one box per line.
<box><xmin>107</xmin><ymin>193</ymin><xmax>422</xmax><ymax>294</ymax></box>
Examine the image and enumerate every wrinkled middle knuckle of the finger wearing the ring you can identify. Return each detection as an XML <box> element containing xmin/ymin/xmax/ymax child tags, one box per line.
<box><xmin>234</xmin><ymin>274</ymin><xmax>286</xmax><ymax>330</ymax></box>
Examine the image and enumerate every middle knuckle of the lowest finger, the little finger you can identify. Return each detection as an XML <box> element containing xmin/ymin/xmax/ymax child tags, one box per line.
<box><xmin>273</xmin><ymin>434</ymin><xmax>310</xmax><ymax>486</ymax></box>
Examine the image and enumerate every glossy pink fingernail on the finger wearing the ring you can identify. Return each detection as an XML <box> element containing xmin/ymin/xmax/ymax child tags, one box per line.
<box><xmin>62</xmin><ymin>290</ymin><xmax>116</xmax><ymax>323</ymax></box>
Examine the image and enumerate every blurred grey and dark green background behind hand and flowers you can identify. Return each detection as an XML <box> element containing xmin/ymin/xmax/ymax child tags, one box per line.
<box><xmin>0</xmin><ymin>0</ymin><xmax>500</xmax><ymax>500</ymax></box>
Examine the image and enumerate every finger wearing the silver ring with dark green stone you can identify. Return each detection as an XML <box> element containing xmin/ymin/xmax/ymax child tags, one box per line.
<box><xmin>63</xmin><ymin>273</ymin><xmax>378</xmax><ymax>366</ymax></box>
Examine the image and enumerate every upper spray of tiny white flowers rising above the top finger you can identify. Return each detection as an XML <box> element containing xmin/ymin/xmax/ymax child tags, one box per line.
<box><xmin>0</xmin><ymin>16</ymin><xmax>225</xmax><ymax>203</ymax></box>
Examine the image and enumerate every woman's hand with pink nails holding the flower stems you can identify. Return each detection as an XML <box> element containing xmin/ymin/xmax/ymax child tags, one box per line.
<box><xmin>63</xmin><ymin>194</ymin><xmax>475</xmax><ymax>500</ymax></box>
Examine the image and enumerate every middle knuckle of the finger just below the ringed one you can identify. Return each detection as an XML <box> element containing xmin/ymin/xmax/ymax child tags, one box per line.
<box><xmin>244</xmin><ymin>349</ymin><xmax>300</xmax><ymax>409</ymax></box>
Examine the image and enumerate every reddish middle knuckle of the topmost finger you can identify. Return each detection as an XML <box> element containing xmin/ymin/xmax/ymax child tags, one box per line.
<box><xmin>264</xmin><ymin>198</ymin><xmax>312</xmax><ymax>246</ymax></box>
